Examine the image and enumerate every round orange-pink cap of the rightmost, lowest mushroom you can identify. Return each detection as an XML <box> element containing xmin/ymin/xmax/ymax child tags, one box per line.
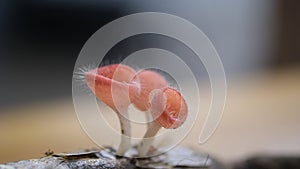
<box><xmin>150</xmin><ymin>87</ymin><xmax>188</xmax><ymax>129</ymax></box>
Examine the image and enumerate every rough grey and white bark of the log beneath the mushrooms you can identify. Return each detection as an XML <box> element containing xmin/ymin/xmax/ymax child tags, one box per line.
<box><xmin>0</xmin><ymin>148</ymin><xmax>223</xmax><ymax>169</ymax></box>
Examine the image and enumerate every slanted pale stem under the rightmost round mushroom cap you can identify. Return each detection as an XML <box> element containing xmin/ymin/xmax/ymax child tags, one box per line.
<box><xmin>138</xmin><ymin>121</ymin><xmax>161</xmax><ymax>157</ymax></box>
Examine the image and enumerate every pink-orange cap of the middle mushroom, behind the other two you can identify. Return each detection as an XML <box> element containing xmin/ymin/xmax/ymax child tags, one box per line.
<box><xmin>130</xmin><ymin>70</ymin><xmax>167</xmax><ymax>111</ymax></box>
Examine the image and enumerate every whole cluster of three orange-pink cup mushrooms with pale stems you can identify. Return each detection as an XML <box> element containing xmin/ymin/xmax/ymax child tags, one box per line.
<box><xmin>85</xmin><ymin>64</ymin><xmax>188</xmax><ymax>157</ymax></box>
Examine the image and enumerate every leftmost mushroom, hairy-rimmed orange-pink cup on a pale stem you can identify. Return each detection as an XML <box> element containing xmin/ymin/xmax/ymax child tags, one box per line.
<box><xmin>85</xmin><ymin>64</ymin><xmax>136</xmax><ymax>155</ymax></box>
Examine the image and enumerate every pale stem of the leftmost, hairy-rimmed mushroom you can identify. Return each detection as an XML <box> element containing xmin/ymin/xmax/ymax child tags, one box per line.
<box><xmin>117</xmin><ymin>110</ymin><xmax>131</xmax><ymax>156</ymax></box>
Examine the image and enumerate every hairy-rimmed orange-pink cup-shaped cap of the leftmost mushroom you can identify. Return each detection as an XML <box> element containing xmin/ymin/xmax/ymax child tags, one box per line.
<box><xmin>85</xmin><ymin>64</ymin><xmax>136</xmax><ymax>111</ymax></box>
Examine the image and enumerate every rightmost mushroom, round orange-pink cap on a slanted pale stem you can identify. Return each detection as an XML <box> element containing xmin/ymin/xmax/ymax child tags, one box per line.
<box><xmin>138</xmin><ymin>87</ymin><xmax>188</xmax><ymax>157</ymax></box>
